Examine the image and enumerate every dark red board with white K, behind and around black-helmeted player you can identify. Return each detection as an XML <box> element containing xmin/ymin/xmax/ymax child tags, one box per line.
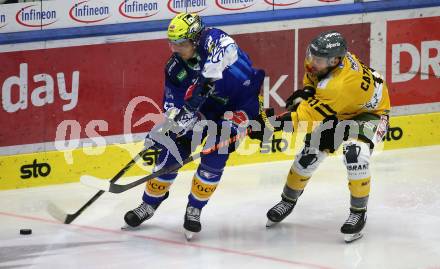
<box><xmin>234</xmin><ymin>23</ymin><xmax>370</xmax><ymax>113</ymax></box>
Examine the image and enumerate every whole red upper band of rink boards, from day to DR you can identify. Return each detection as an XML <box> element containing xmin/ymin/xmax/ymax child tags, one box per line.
<box><xmin>0</xmin><ymin>11</ymin><xmax>440</xmax><ymax>149</ymax></box>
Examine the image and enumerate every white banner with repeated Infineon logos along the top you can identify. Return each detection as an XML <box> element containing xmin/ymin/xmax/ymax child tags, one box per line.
<box><xmin>0</xmin><ymin>0</ymin><xmax>353</xmax><ymax>33</ymax></box>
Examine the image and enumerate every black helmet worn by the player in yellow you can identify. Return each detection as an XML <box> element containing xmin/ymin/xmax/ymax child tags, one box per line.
<box><xmin>309</xmin><ymin>31</ymin><xmax>347</xmax><ymax>58</ymax></box>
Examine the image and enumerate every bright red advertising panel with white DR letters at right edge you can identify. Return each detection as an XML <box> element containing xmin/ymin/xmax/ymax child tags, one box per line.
<box><xmin>386</xmin><ymin>17</ymin><xmax>440</xmax><ymax>105</ymax></box>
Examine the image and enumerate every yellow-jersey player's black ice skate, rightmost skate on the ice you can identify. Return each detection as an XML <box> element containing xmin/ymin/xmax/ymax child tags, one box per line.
<box><xmin>341</xmin><ymin>208</ymin><xmax>367</xmax><ymax>243</ymax></box>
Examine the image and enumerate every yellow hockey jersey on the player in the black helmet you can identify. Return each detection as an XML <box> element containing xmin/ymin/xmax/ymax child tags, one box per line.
<box><xmin>292</xmin><ymin>52</ymin><xmax>390</xmax><ymax>124</ymax></box>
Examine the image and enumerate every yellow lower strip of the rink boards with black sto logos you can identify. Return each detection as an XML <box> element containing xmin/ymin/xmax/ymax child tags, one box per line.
<box><xmin>0</xmin><ymin>110</ymin><xmax>440</xmax><ymax>190</ymax></box>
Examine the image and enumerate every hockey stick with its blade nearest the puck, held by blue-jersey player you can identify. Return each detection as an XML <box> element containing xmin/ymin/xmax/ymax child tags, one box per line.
<box><xmin>47</xmin><ymin>148</ymin><xmax>148</xmax><ymax>224</ymax></box>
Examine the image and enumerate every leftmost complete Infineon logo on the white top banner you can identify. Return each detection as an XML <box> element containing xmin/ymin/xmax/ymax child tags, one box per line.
<box><xmin>15</xmin><ymin>5</ymin><xmax>57</xmax><ymax>27</ymax></box>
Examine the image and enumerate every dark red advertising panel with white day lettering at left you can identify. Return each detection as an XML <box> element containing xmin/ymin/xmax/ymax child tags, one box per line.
<box><xmin>0</xmin><ymin>40</ymin><xmax>170</xmax><ymax>146</ymax></box>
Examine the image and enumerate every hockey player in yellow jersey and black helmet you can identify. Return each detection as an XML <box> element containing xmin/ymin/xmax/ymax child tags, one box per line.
<box><xmin>266</xmin><ymin>31</ymin><xmax>390</xmax><ymax>242</ymax></box>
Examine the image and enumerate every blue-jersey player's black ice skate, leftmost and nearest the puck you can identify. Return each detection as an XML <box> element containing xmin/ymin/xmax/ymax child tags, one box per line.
<box><xmin>121</xmin><ymin>192</ymin><xmax>169</xmax><ymax>228</ymax></box>
